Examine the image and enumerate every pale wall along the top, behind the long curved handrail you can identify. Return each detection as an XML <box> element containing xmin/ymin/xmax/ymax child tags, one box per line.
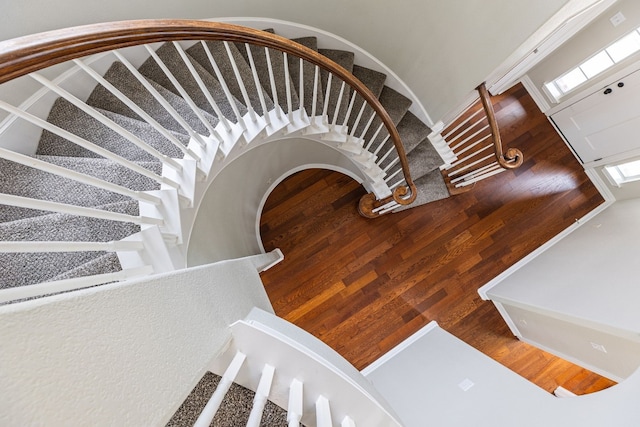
<box><xmin>0</xmin><ymin>0</ymin><xmax>576</xmax><ymax>121</ymax></box>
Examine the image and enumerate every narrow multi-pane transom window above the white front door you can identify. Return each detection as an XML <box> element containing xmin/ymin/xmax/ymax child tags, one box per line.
<box><xmin>544</xmin><ymin>28</ymin><xmax>640</xmax><ymax>101</ymax></box>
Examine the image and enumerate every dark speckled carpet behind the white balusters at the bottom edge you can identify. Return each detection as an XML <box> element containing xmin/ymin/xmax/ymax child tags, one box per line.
<box><xmin>166</xmin><ymin>372</ymin><xmax>288</xmax><ymax>427</ymax></box>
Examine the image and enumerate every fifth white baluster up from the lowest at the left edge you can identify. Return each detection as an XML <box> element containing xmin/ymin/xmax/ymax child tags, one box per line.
<box><xmin>0</xmin><ymin>101</ymin><xmax>180</xmax><ymax>189</ymax></box>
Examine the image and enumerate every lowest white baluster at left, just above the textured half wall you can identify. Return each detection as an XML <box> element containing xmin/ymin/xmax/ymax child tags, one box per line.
<box><xmin>0</xmin><ymin>266</ymin><xmax>153</xmax><ymax>303</ymax></box>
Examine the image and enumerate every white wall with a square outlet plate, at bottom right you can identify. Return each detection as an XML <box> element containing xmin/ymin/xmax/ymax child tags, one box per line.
<box><xmin>363</xmin><ymin>322</ymin><xmax>640</xmax><ymax>427</ymax></box>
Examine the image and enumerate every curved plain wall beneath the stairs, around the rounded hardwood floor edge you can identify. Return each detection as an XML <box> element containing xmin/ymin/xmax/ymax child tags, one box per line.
<box><xmin>187</xmin><ymin>138</ymin><xmax>363</xmax><ymax>267</ymax></box>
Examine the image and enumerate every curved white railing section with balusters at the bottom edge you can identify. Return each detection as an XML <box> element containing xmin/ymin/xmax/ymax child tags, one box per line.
<box><xmin>200</xmin><ymin>309</ymin><xmax>400</xmax><ymax>427</ymax></box>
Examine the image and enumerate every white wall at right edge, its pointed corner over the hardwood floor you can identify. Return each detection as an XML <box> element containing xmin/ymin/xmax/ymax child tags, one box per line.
<box><xmin>488</xmin><ymin>199</ymin><xmax>640</xmax><ymax>379</ymax></box>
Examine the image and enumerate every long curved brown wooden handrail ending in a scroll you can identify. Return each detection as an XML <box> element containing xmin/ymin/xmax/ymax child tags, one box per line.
<box><xmin>0</xmin><ymin>19</ymin><xmax>417</xmax><ymax>212</ymax></box>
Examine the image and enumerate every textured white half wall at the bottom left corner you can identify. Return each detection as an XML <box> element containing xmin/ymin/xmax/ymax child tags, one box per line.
<box><xmin>0</xmin><ymin>255</ymin><xmax>273</xmax><ymax>427</ymax></box>
